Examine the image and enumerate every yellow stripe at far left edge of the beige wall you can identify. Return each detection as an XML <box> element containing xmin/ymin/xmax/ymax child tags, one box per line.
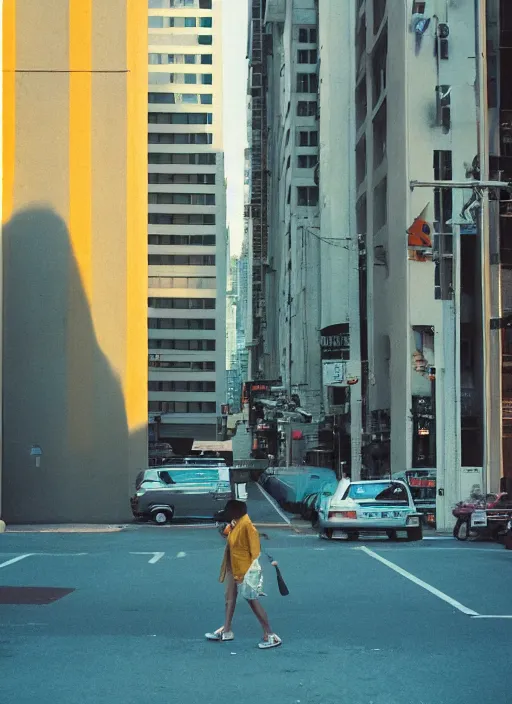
<box><xmin>2</xmin><ymin>0</ymin><xmax>16</xmax><ymax>222</ymax></box>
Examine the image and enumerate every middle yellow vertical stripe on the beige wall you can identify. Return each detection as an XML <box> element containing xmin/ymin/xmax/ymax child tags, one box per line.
<box><xmin>69</xmin><ymin>0</ymin><xmax>92</xmax><ymax>304</ymax></box>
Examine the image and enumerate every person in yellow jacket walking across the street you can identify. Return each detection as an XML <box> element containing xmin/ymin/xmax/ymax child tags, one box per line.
<box><xmin>206</xmin><ymin>500</ymin><xmax>282</xmax><ymax>650</ymax></box>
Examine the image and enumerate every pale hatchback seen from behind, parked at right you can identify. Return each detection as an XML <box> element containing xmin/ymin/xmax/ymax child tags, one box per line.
<box><xmin>317</xmin><ymin>479</ymin><xmax>423</xmax><ymax>540</ymax></box>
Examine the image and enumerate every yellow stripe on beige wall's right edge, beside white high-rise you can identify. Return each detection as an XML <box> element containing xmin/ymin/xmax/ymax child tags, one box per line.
<box><xmin>125</xmin><ymin>0</ymin><xmax>148</xmax><ymax>432</ymax></box>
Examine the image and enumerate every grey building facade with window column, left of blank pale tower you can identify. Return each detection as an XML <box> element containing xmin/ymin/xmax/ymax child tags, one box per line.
<box><xmin>265</xmin><ymin>0</ymin><xmax>322</xmax><ymax>419</ymax></box>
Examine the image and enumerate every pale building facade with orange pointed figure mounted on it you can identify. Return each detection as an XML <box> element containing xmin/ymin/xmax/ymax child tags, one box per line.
<box><xmin>355</xmin><ymin>0</ymin><xmax>484</xmax><ymax>526</ymax></box>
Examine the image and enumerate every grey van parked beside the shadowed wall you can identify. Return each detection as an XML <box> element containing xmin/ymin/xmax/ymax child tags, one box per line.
<box><xmin>131</xmin><ymin>465</ymin><xmax>234</xmax><ymax>524</ymax></box>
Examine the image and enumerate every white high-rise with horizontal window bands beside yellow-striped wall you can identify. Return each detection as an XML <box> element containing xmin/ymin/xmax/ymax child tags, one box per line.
<box><xmin>148</xmin><ymin>0</ymin><xmax>227</xmax><ymax>449</ymax></box>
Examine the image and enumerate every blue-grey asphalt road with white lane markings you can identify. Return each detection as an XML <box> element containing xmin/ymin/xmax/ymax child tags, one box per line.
<box><xmin>0</xmin><ymin>516</ymin><xmax>512</xmax><ymax>704</ymax></box>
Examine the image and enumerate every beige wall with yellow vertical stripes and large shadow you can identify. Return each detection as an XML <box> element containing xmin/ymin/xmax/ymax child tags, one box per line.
<box><xmin>3</xmin><ymin>0</ymin><xmax>147</xmax><ymax>522</ymax></box>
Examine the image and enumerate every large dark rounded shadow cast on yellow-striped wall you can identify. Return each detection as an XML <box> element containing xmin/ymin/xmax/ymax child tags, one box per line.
<box><xmin>3</xmin><ymin>207</ymin><xmax>145</xmax><ymax>523</ymax></box>
